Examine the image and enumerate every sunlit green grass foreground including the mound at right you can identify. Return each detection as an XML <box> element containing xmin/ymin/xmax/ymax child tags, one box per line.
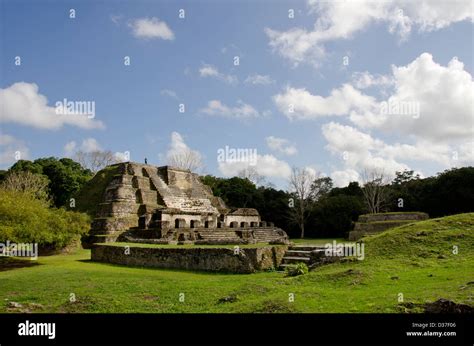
<box><xmin>0</xmin><ymin>213</ymin><xmax>474</xmax><ymax>313</ymax></box>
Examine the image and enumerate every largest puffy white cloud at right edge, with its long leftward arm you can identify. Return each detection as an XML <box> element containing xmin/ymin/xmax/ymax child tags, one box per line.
<box><xmin>273</xmin><ymin>53</ymin><xmax>474</xmax><ymax>143</ymax></box>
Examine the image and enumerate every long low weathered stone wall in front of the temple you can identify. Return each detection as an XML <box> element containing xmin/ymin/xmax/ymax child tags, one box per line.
<box><xmin>91</xmin><ymin>244</ymin><xmax>288</xmax><ymax>274</ymax></box>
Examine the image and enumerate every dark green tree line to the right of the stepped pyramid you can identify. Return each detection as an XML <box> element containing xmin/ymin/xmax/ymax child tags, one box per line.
<box><xmin>202</xmin><ymin>167</ymin><xmax>474</xmax><ymax>238</ymax></box>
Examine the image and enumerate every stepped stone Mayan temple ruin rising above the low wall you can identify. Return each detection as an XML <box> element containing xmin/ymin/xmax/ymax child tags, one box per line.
<box><xmin>84</xmin><ymin>162</ymin><xmax>288</xmax><ymax>245</ymax></box>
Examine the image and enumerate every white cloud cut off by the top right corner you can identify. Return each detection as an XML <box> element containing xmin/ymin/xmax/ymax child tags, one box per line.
<box><xmin>265</xmin><ymin>0</ymin><xmax>473</xmax><ymax>66</ymax></box>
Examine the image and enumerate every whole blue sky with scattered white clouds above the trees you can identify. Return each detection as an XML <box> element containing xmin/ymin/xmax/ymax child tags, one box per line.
<box><xmin>0</xmin><ymin>0</ymin><xmax>474</xmax><ymax>187</ymax></box>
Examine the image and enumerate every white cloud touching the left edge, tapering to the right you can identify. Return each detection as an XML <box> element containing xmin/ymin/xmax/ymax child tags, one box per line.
<box><xmin>0</xmin><ymin>82</ymin><xmax>104</xmax><ymax>130</ymax></box>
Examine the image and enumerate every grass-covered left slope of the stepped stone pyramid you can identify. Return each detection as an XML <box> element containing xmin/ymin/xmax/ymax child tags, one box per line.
<box><xmin>75</xmin><ymin>165</ymin><xmax>119</xmax><ymax>217</ymax></box>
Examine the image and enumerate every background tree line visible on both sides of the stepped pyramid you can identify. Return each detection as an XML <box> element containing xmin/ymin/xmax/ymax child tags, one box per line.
<box><xmin>0</xmin><ymin>157</ymin><xmax>474</xmax><ymax>241</ymax></box>
